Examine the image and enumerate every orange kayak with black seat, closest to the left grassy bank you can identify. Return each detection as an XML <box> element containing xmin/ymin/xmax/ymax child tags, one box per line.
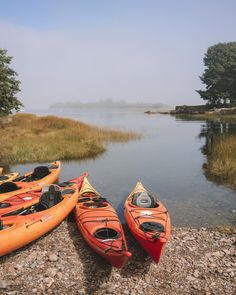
<box><xmin>0</xmin><ymin>161</ymin><xmax>61</xmax><ymax>202</ymax></box>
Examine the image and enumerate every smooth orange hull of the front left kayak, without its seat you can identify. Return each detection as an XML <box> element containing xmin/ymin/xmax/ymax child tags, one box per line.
<box><xmin>0</xmin><ymin>176</ymin><xmax>87</xmax><ymax>256</ymax></box>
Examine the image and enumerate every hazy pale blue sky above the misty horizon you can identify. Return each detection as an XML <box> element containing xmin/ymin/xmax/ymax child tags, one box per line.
<box><xmin>0</xmin><ymin>0</ymin><xmax>236</xmax><ymax>107</ymax></box>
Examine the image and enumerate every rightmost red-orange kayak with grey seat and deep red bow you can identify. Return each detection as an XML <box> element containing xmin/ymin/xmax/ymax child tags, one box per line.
<box><xmin>124</xmin><ymin>182</ymin><xmax>171</xmax><ymax>263</ymax></box>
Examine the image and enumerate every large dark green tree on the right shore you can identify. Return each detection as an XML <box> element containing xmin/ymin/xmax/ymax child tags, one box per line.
<box><xmin>197</xmin><ymin>42</ymin><xmax>236</xmax><ymax>106</ymax></box>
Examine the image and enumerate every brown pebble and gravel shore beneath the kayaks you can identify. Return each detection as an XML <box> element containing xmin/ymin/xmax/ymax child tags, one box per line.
<box><xmin>0</xmin><ymin>220</ymin><xmax>236</xmax><ymax>295</ymax></box>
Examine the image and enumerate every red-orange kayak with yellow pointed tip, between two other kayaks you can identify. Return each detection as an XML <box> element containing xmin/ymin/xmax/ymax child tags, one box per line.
<box><xmin>75</xmin><ymin>177</ymin><xmax>131</xmax><ymax>268</ymax></box>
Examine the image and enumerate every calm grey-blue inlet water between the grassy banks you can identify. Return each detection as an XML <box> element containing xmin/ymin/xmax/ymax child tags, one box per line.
<box><xmin>11</xmin><ymin>109</ymin><xmax>236</xmax><ymax>227</ymax></box>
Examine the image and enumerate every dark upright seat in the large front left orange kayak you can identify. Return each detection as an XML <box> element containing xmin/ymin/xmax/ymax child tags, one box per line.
<box><xmin>37</xmin><ymin>185</ymin><xmax>63</xmax><ymax>211</ymax></box>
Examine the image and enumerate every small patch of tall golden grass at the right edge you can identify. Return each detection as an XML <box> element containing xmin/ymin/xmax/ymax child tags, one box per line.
<box><xmin>206</xmin><ymin>135</ymin><xmax>236</xmax><ymax>189</ymax></box>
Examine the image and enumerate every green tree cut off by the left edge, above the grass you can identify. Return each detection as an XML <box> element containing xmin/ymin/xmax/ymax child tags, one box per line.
<box><xmin>0</xmin><ymin>48</ymin><xmax>23</xmax><ymax>116</ymax></box>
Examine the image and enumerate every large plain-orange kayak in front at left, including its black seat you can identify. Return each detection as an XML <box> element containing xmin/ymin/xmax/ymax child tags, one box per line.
<box><xmin>0</xmin><ymin>178</ymin><xmax>86</xmax><ymax>256</ymax></box>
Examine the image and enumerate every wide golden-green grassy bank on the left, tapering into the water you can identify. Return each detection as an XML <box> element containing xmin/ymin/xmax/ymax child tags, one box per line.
<box><xmin>0</xmin><ymin>114</ymin><xmax>139</xmax><ymax>164</ymax></box>
